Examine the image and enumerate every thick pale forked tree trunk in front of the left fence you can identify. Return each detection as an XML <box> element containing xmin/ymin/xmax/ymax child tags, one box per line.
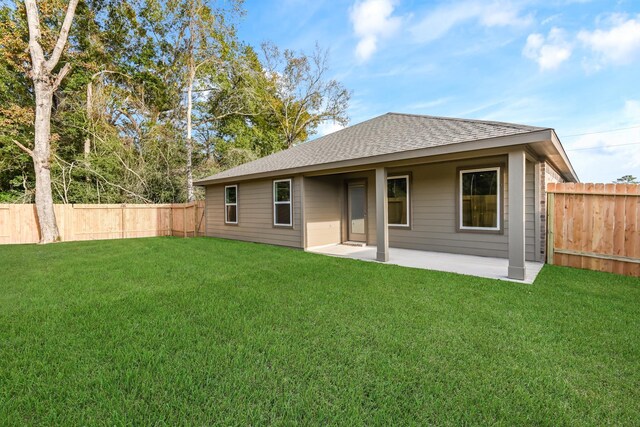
<box><xmin>15</xmin><ymin>0</ymin><xmax>78</xmax><ymax>243</ymax></box>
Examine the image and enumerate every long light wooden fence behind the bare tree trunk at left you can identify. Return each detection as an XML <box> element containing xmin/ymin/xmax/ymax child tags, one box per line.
<box><xmin>0</xmin><ymin>201</ymin><xmax>205</xmax><ymax>244</ymax></box>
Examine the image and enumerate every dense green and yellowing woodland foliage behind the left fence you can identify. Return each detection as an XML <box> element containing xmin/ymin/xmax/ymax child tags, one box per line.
<box><xmin>0</xmin><ymin>0</ymin><xmax>346</xmax><ymax>203</ymax></box>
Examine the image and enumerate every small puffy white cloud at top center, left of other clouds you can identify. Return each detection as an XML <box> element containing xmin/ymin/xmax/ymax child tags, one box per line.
<box><xmin>350</xmin><ymin>0</ymin><xmax>402</xmax><ymax>61</ymax></box>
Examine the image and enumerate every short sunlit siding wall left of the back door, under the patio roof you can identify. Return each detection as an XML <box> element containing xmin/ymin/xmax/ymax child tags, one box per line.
<box><xmin>304</xmin><ymin>176</ymin><xmax>343</xmax><ymax>247</ymax></box>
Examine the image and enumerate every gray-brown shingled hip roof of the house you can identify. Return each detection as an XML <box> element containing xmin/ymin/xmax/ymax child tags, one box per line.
<box><xmin>197</xmin><ymin>113</ymin><xmax>548</xmax><ymax>183</ymax></box>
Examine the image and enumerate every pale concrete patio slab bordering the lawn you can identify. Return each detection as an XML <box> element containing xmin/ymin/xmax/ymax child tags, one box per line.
<box><xmin>307</xmin><ymin>245</ymin><xmax>544</xmax><ymax>284</ymax></box>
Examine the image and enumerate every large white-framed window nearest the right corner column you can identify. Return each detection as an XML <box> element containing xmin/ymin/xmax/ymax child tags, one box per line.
<box><xmin>458</xmin><ymin>167</ymin><xmax>502</xmax><ymax>231</ymax></box>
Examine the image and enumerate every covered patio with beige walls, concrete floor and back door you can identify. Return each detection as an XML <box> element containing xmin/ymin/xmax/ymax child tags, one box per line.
<box><xmin>301</xmin><ymin>148</ymin><xmax>542</xmax><ymax>283</ymax></box>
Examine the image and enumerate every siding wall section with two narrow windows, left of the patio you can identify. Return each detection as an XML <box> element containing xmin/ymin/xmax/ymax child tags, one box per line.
<box><xmin>206</xmin><ymin>177</ymin><xmax>303</xmax><ymax>248</ymax></box>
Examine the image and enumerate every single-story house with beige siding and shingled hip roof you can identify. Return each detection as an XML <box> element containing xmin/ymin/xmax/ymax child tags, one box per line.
<box><xmin>196</xmin><ymin>113</ymin><xmax>578</xmax><ymax>280</ymax></box>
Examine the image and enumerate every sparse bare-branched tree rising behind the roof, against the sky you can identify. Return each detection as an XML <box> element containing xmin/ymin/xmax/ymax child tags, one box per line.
<box><xmin>262</xmin><ymin>43</ymin><xmax>351</xmax><ymax>148</ymax></box>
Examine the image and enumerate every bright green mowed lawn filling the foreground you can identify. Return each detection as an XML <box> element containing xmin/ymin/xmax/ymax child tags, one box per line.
<box><xmin>0</xmin><ymin>238</ymin><xmax>640</xmax><ymax>426</ymax></box>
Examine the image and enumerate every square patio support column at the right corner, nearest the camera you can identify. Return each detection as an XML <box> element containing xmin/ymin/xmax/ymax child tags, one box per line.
<box><xmin>508</xmin><ymin>151</ymin><xmax>526</xmax><ymax>280</ymax></box>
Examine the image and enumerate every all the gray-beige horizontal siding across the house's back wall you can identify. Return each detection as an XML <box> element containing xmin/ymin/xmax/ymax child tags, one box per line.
<box><xmin>206</xmin><ymin>156</ymin><xmax>536</xmax><ymax>261</ymax></box>
